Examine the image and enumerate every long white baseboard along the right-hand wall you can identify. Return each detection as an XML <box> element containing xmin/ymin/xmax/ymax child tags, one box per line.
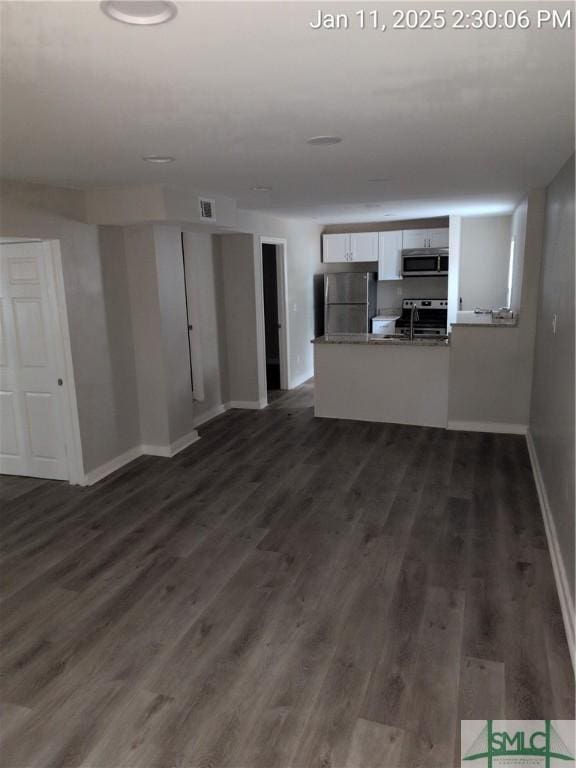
<box><xmin>526</xmin><ymin>431</ymin><xmax>576</xmax><ymax>666</ymax></box>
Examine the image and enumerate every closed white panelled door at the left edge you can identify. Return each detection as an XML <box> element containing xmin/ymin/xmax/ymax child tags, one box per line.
<box><xmin>0</xmin><ymin>242</ymin><xmax>69</xmax><ymax>480</ymax></box>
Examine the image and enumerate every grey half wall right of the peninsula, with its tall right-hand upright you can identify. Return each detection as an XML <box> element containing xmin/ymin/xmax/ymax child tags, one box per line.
<box><xmin>448</xmin><ymin>190</ymin><xmax>545</xmax><ymax>431</ymax></box>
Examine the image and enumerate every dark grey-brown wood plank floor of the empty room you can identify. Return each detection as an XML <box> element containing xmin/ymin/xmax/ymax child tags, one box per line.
<box><xmin>0</xmin><ymin>384</ymin><xmax>574</xmax><ymax>768</ymax></box>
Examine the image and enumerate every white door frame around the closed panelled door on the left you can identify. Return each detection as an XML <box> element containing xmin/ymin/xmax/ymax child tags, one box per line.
<box><xmin>0</xmin><ymin>237</ymin><xmax>86</xmax><ymax>485</ymax></box>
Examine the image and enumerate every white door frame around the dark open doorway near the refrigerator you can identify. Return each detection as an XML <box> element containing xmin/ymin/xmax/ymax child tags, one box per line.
<box><xmin>255</xmin><ymin>235</ymin><xmax>292</xmax><ymax>403</ymax></box>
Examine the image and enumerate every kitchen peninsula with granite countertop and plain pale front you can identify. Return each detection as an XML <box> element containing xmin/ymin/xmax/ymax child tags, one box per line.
<box><xmin>313</xmin><ymin>334</ymin><xmax>450</xmax><ymax>427</ymax></box>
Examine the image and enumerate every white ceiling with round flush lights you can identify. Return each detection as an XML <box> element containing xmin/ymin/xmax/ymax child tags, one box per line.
<box><xmin>0</xmin><ymin>2</ymin><xmax>574</xmax><ymax>223</ymax></box>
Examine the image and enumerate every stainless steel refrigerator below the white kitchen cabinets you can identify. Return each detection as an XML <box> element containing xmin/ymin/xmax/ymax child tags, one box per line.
<box><xmin>324</xmin><ymin>272</ymin><xmax>376</xmax><ymax>335</ymax></box>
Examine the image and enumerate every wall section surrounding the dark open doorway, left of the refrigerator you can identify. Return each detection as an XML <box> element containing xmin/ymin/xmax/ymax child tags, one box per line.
<box><xmin>184</xmin><ymin>211</ymin><xmax>321</xmax><ymax>421</ymax></box>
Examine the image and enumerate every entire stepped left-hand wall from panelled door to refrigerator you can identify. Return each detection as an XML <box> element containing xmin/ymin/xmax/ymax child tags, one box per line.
<box><xmin>0</xmin><ymin>183</ymin><xmax>321</xmax><ymax>472</ymax></box>
